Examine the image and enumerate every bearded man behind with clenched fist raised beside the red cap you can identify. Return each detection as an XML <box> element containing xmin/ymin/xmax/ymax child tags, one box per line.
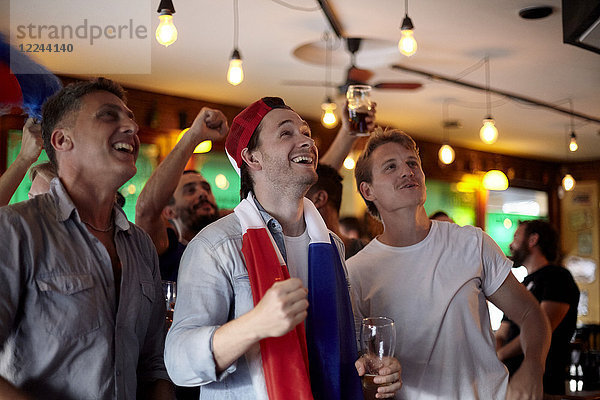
<box><xmin>135</xmin><ymin>107</ymin><xmax>228</xmax><ymax>281</ymax></box>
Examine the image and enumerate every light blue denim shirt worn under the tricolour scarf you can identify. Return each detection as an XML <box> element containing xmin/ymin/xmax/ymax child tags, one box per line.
<box><xmin>165</xmin><ymin>198</ymin><xmax>344</xmax><ymax>400</ymax></box>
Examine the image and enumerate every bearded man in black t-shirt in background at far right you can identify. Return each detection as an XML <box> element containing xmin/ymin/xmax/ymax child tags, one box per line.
<box><xmin>496</xmin><ymin>220</ymin><xmax>579</xmax><ymax>394</ymax></box>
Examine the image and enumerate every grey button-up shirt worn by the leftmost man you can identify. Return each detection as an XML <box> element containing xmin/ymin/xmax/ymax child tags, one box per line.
<box><xmin>0</xmin><ymin>179</ymin><xmax>168</xmax><ymax>400</ymax></box>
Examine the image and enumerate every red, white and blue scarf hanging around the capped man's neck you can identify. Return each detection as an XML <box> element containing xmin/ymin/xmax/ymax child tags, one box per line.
<box><xmin>234</xmin><ymin>193</ymin><xmax>363</xmax><ymax>400</ymax></box>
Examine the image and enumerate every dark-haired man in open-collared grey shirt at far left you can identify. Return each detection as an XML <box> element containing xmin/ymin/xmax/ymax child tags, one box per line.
<box><xmin>0</xmin><ymin>78</ymin><xmax>172</xmax><ymax>400</ymax></box>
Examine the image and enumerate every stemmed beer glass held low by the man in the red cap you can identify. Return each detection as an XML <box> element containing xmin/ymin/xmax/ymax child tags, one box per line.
<box><xmin>360</xmin><ymin>317</ymin><xmax>396</xmax><ymax>399</ymax></box>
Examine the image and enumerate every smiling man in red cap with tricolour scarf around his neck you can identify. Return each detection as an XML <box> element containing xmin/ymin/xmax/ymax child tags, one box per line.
<box><xmin>165</xmin><ymin>97</ymin><xmax>401</xmax><ymax>400</ymax></box>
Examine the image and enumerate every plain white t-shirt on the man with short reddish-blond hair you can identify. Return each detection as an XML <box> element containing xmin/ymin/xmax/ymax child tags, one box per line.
<box><xmin>346</xmin><ymin>221</ymin><xmax>512</xmax><ymax>400</ymax></box>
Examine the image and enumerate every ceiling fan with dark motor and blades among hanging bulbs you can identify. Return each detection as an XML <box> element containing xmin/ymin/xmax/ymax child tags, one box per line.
<box><xmin>284</xmin><ymin>38</ymin><xmax>423</xmax><ymax>94</ymax></box>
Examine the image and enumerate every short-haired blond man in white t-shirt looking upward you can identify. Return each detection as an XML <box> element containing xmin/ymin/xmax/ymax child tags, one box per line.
<box><xmin>347</xmin><ymin>129</ymin><xmax>550</xmax><ymax>400</ymax></box>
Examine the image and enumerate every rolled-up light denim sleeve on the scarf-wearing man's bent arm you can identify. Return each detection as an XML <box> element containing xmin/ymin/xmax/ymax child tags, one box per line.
<box><xmin>165</xmin><ymin>236</ymin><xmax>236</xmax><ymax>386</ymax></box>
